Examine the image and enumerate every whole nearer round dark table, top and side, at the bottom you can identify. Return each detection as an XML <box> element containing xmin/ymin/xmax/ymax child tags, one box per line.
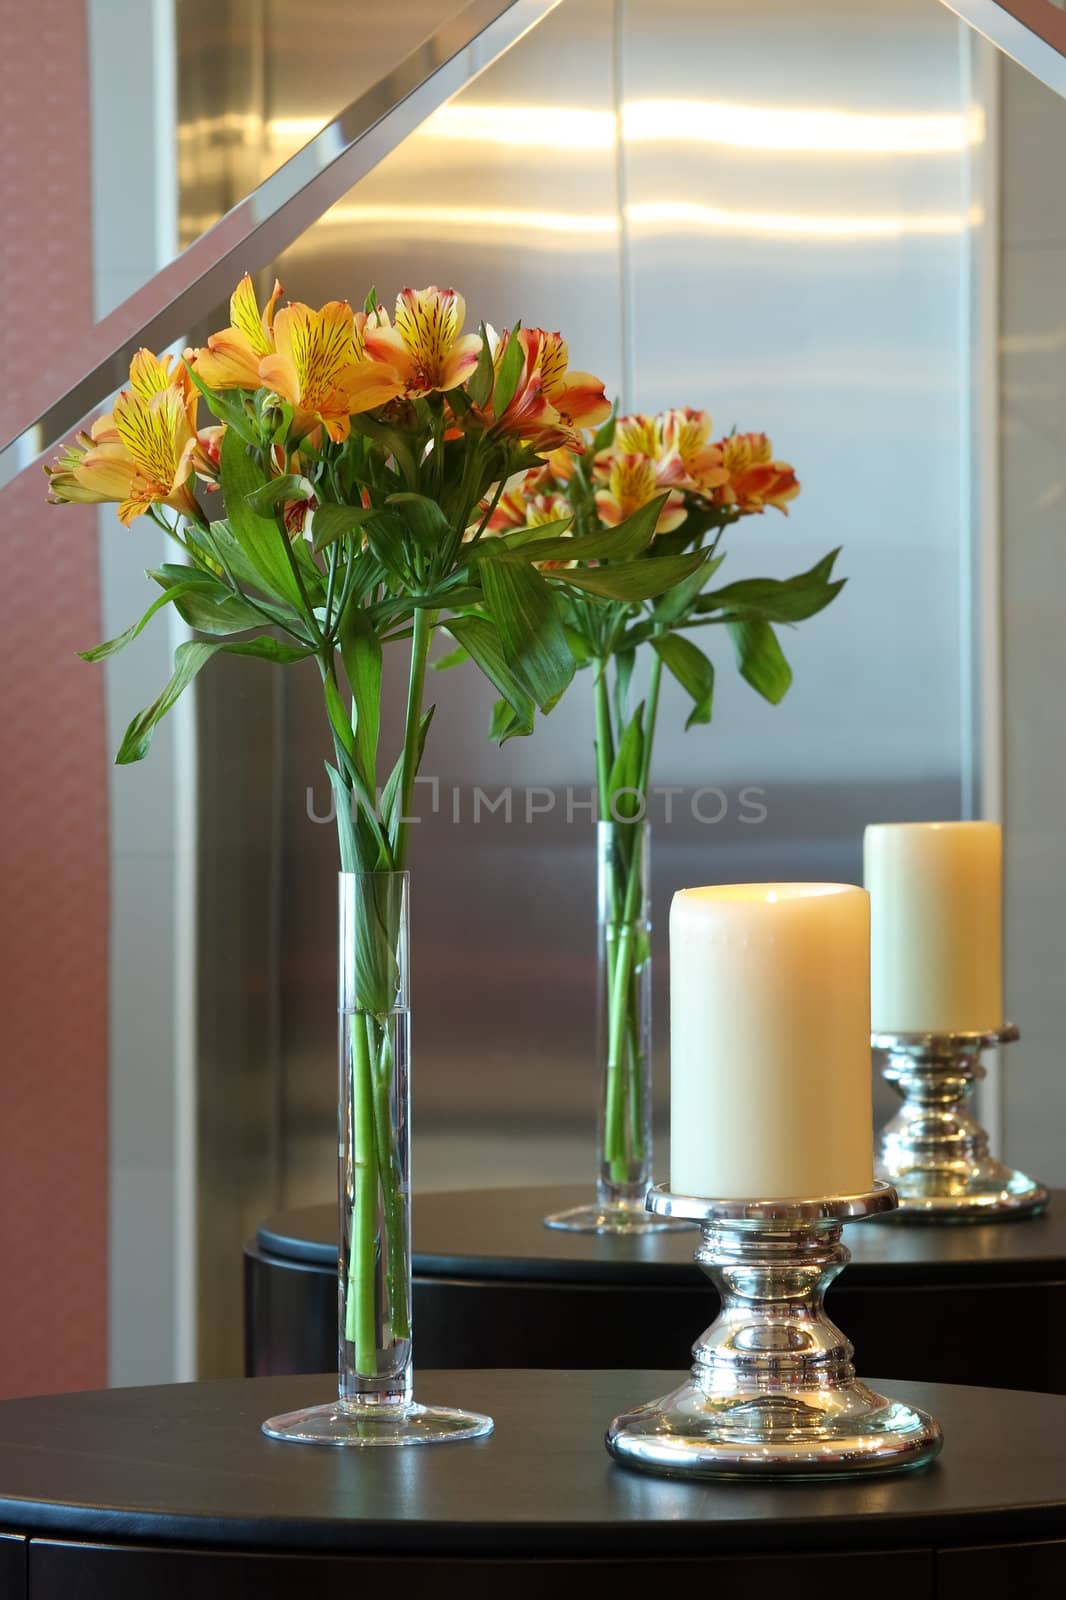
<box><xmin>0</xmin><ymin>1370</ymin><xmax>1066</xmax><ymax>1600</ymax></box>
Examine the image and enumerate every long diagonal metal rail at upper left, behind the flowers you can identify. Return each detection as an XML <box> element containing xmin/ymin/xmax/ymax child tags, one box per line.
<box><xmin>0</xmin><ymin>0</ymin><xmax>560</xmax><ymax>488</ymax></box>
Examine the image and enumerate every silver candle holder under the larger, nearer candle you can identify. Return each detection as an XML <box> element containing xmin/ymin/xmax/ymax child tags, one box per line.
<box><xmin>607</xmin><ymin>1184</ymin><xmax>943</xmax><ymax>1478</ymax></box>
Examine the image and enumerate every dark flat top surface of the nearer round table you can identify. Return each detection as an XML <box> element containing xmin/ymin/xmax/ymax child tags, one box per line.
<box><xmin>0</xmin><ymin>1371</ymin><xmax>1066</xmax><ymax>1557</ymax></box>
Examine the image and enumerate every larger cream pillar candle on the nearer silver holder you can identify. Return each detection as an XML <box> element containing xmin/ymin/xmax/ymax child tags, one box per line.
<box><xmin>671</xmin><ymin>883</ymin><xmax>874</xmax><ymax>1200</ymax></box>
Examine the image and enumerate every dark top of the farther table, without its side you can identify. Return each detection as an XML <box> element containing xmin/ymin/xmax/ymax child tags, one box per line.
<box><xmin>258</xmin><ymin>1186</ymin><xmax>1066</xmax><ymax>1288</ymax></box>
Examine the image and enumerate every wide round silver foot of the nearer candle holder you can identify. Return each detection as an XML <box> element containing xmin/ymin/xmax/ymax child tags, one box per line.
<box><xmin>607</xmin><ymin>1379</ymin><xmax>943</xmax><ymax>1478</ymax></box>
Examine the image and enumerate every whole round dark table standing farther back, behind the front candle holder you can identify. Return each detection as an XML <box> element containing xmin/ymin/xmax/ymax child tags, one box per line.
<box><xmin>245</xmin><ymin>1187</ymin><xmax>1066</xmax><ymax>1395</ymax></box>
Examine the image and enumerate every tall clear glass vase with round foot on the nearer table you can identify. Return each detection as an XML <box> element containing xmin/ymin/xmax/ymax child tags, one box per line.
<box><xmin>262</xmin><ymin>872</ymin><xmax>493</xmax><ymax>1445</ymax></box>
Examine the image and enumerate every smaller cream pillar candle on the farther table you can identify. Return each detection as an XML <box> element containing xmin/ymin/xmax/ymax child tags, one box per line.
<box><xmin>864</xmin><ymin>822</ymin><xmax>1004</xmax><ymax>1034</ymax></box>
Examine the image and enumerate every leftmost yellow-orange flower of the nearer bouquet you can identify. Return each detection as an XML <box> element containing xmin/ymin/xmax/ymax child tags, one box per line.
<box><xmin>45</xmin><ymin>350</ymin><xmax>201</xmax><ymax>525</ymax></box>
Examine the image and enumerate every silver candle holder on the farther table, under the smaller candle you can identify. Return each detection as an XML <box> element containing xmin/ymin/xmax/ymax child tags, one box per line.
<box><xmin>871</xmin><ymin>1022</ymin><xmax>1048</xmax><ymax>1222</ymax></box>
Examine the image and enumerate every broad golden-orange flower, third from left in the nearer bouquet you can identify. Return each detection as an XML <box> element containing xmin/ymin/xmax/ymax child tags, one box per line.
<box><xmin>259</xmin><ymin>301</ymin><xmax>403</xmax><ymax>442</ymax></box>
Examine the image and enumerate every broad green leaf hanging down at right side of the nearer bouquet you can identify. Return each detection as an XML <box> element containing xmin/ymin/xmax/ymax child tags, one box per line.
<box><xmin>476</xmin><ymin>562</ymin><xmax>575</xmax><ymax>710</ymax></box>
